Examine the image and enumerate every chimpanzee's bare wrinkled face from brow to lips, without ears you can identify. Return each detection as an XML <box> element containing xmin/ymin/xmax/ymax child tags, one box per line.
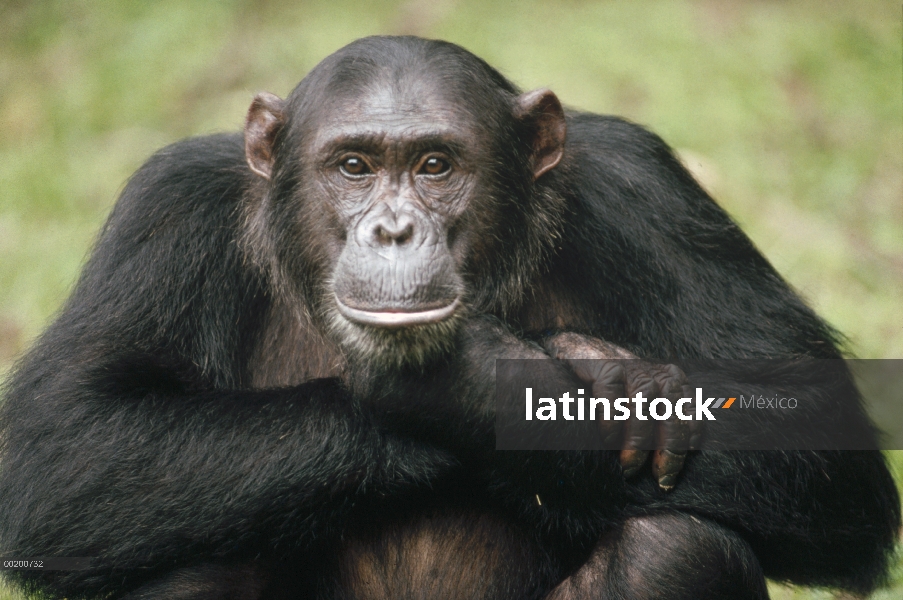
<box><xmin>310</xmin><ymin>79</ymin><xmax>480</xmax><ymax>329</ymax></box>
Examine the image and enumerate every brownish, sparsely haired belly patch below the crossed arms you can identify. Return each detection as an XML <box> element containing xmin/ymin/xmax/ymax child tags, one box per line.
<box><xmin>317</xmin><ymin>508</ymin><xmax>561</xmax><ymax>600</ymax></box>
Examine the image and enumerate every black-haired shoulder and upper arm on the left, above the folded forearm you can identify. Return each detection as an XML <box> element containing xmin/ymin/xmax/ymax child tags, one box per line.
<box><xmin>35</xmin><ymin>134</ymin><xmax>266</xmax><ymax>387</ymax></box>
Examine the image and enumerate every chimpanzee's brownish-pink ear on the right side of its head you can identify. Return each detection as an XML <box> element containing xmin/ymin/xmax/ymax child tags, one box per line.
<box><xmin>515</xmin><ymin>90</ymin><xmax>567</xmax><ymax>179</ymax></box>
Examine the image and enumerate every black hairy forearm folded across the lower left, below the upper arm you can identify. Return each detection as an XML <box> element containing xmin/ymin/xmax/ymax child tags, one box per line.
<box><xmin>0</xmin><ymin>378</ymin><xmax>452</xmax><ymax>592</ymax></box>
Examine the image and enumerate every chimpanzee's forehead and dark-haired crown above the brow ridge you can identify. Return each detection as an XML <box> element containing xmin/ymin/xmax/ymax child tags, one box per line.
<box><xmin>297</xmin><ymin>38</ymin><xmax>516</xmax><ymax>149</ymax></box>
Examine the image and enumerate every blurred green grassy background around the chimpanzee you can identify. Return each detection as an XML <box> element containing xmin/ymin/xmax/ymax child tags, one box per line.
<box><xmin>0</xmin><ymin>0</ymin><xmax>903</xmax><ymax>600</ymax></box>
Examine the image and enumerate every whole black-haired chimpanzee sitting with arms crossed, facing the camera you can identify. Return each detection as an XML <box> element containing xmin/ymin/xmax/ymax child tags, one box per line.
<box><xmin>0</xmin><ymin>37</ymin><xmax>900</xmax><ymax>599</ymax></box>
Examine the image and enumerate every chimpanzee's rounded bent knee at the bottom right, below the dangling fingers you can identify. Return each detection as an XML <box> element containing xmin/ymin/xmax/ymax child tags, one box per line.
<box><xmin>546</xmin><ymin>514</ymin><xmax>768</xmax><ymax>600</ymax></box>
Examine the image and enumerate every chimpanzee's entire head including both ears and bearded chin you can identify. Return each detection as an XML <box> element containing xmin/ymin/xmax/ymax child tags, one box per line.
<box><xmin>245</xmin><ymin>37</ymin><xmax>565</xmax><ymax>363</ymax></box>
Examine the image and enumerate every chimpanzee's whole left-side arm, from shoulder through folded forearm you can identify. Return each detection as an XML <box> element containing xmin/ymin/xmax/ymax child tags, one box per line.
<box><xmin>0</xmin><ymin>136</ymin><xmax>453</xmax><ymax>593</ymax></box>
